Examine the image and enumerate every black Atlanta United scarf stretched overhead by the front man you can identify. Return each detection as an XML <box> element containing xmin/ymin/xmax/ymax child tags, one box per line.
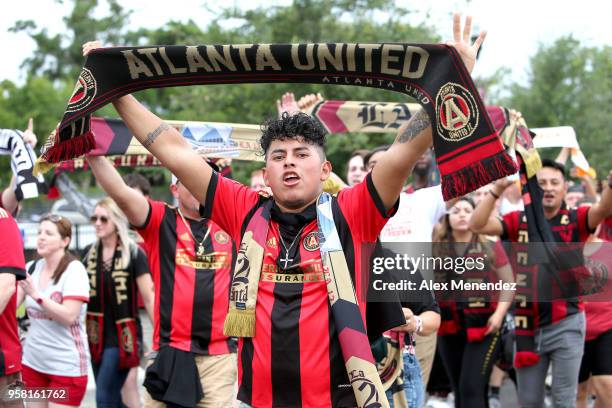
<box><xmin>38</xmin><ymin>43</ymin><xmax>516</xmax><ymax>200</ymax></box>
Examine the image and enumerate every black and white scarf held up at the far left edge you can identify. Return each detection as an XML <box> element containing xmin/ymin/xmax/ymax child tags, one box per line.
<box><xmin>0</xmin><ymin>129</ymin><xmax>47</xmax><ymax>201</ymax></box>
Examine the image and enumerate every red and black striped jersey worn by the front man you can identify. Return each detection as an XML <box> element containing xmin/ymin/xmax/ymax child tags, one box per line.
<box><xmin>201</xmin><ymin>173</ymin><xmax>403</xmax><ymax>408</ymax></box>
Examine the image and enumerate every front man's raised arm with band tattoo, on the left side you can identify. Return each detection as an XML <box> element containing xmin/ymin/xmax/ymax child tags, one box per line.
<box><xmin>83</xmin><ymin>41</ymin><xmax>212</xmax><ymax>202</ymax></box>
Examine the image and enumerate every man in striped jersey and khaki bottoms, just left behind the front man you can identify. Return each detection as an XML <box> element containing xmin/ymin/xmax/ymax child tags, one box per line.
<box><xmin>88</xmin><ymin>157</ymin><xmax>236</xmax><ymax>406</ymax></box>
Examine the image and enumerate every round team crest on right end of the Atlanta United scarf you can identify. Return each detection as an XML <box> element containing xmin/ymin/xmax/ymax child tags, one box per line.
<box><xmin>436</xmin><ymin>82</ymin><xmax>479</xmax><ymax>142</ymax></box>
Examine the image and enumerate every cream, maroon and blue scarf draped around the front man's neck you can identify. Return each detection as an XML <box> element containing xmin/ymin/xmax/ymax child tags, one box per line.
<box><xmin>223</xmin><ymin>193</ymin><xmax>388</xmax><ymax>407</ymax></box>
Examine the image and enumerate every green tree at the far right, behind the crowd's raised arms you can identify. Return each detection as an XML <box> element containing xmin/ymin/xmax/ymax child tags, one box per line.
<box><xmin>503</xmin><ymin>36</ymin><xmax>612</xmax><ymax>176</ymax></box>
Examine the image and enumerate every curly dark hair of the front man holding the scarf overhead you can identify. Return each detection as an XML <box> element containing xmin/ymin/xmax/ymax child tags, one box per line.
<box><xmin>259</xmin><ymin>112</ymin><xmax>326</xmax><ymax>155</ymax></box>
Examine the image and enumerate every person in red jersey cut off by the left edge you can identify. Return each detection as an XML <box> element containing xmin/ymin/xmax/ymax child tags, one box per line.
<box><xmin>0</xmin><ymin>207</ymin><xmax>26</xmax><ymax>407</ymax></box>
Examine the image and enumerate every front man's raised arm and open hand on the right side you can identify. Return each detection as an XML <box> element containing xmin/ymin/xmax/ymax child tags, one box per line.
<box><xmin>372</xmin><ymin>14</ymin><xmax>486</xmax><ymax>209</ymax></box>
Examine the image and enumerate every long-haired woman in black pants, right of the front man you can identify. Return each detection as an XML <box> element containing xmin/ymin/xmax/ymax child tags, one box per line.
<box><xmin>433</xmin><ymin>197</ymin><xmax>513</xmax><ymax>408</ymax></box>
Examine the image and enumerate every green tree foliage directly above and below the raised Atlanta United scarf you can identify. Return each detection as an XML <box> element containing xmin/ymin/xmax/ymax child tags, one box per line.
<box><xmin>126</xmin><ymin>0</ymin><xmax>440</xmax><ymax>181</ymax></box>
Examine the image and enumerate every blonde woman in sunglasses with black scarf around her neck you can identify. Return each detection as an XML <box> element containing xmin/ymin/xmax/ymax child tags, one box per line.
<box><xmin>83</xmin><ymin>197</ymin><xmax>154</xmax><ymax>407</ymax></box>
